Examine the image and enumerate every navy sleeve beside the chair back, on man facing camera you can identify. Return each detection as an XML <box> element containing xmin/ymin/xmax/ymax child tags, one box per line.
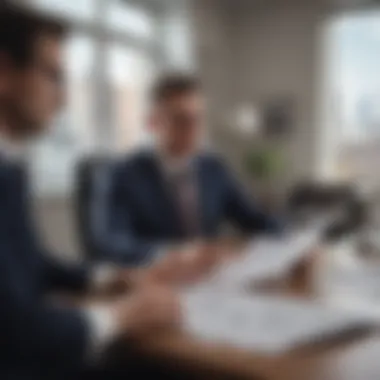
<box><xmin>91</xmin><ymin>166</ymin><xmax>163</xmax><ymax>266</ymax></box>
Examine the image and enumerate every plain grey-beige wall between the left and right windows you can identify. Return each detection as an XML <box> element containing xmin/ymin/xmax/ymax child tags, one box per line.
<box><xmin>191</xmin><ymin>0</ymin><xmax>327</xmax><ymax>194</ymax></box>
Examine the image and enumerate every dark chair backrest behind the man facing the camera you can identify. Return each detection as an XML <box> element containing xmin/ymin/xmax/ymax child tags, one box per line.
<box><xmin>75</xmin><ymin>157</ymin><xmax>112</xmax><ymax>260</ymax></box>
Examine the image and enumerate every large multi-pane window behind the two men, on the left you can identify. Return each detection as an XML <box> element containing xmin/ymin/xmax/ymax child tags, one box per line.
<box><xmin>28</xmin><ymin>0</ymin><xmax>191</xmax><ymax>196</ymax></box>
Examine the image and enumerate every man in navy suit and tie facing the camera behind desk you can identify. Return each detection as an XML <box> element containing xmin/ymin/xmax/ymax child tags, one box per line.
<box><xmin>92</xmin><ymin>74</ymin><xmax>280</xmax><ymax>265</ymax></box>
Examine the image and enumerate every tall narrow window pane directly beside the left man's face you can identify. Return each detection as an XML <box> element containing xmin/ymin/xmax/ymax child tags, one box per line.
<box><xmin>32</xmin><ymin>35</ymin><xmax>94</xmax><ymax>194</ymax></box>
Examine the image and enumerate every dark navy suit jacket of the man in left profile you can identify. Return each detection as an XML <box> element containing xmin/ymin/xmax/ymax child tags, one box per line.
<box><xmin>0</xmin><ymin>160</ymin><xmax>89</xmax><ymax>379</ymax></box>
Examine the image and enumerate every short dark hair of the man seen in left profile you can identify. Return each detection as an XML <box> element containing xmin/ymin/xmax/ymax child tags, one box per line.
<box><xmin>0</xmin><ymin>3</ymin><xmax>69</xmax><ymax>66</ymax></box>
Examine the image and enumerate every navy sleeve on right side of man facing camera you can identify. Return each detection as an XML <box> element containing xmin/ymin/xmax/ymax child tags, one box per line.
<box><xmin>222</xmin><ymin>163</ymin><xmax>282</xmax><ymax>233</ymax></box>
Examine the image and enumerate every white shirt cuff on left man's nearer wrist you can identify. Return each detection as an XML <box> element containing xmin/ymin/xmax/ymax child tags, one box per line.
<box><xmin>84</xmin><ymin>306</ymin><xmax>119</xmax><ymax>363</ymax></box>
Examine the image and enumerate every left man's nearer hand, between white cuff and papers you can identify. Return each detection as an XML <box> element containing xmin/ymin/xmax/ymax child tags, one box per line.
<box><xmin>113</xmin><ymin>286</ymin><xmax>181</xmax><ymax>335</ymax></box>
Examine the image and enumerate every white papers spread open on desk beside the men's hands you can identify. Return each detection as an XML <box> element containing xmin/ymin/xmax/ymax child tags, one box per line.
<box><xmin>182</xmin><ymin>217</ymin><xmax>374</xmax><ymax>353</ymax></box>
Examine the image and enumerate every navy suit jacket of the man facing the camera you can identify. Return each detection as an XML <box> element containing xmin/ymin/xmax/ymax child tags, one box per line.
<box><xmin>92</xmin><ymin>151</ymin><xmax>280</xmax><ymax>265</ymax></box>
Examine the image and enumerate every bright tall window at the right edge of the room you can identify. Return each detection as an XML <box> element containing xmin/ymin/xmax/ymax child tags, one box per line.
<box><xmin>320</xmin><ymin>10</ymin><xmax>380</xmax><ymax>183</ymax></box>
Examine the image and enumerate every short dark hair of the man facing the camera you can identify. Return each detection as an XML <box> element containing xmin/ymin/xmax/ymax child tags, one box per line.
<box><xmin>151</xmin><ymin>73</ymin><xmax>202</xmax><ymax>103</ymax></box>
